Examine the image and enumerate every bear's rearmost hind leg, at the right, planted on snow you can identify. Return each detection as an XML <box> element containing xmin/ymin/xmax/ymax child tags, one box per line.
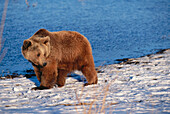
<box><xmin>81</xmin><ymin>65</ymin><xmax>98</xmax><ymax>86</ymax></box>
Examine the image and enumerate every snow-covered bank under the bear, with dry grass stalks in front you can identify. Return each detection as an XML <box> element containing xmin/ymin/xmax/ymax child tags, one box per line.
<box><xmin>0</xmin><ymin>50</ymin><xmax>170</xmax><ymax>114</ymax></box>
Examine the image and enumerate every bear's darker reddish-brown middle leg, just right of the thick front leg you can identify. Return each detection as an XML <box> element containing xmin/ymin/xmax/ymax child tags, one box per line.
<box><xmin>57</xmin><ymin>69</ymin><xmax>69</xmax><ymax>87</ymax></box>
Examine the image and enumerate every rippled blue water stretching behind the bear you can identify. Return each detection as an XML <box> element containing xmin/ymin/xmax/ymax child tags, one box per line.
<box><xmin>0</xmin><ymin>0</ymin><xmax>170</xmax><ymax>74</ymax></box>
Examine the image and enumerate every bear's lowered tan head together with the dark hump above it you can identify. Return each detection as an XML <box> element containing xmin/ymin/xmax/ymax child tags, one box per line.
<box><xmin>22</xmin><ymin>29</ymin><xmax>50</xmax><ymax>67</ymax></box>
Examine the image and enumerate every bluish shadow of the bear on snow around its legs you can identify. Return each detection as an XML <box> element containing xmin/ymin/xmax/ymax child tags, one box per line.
<box><xmin>26</xmin><ymin>73</ymin><xmax>87</xmax><ymax>87</ymax></box>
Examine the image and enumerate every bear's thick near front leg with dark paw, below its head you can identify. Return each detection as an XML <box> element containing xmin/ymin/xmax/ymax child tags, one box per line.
<box><xmin>32</xmin><ymin>62</ymin><xmax>58</xmax><ymax>90</ymax></box>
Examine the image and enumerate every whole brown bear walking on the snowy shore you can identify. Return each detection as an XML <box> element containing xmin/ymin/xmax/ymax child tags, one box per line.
<box><xmin>22</xmin><ymin>29</ymin><xmax>98</xmax><ymax>90</ymax></box>
